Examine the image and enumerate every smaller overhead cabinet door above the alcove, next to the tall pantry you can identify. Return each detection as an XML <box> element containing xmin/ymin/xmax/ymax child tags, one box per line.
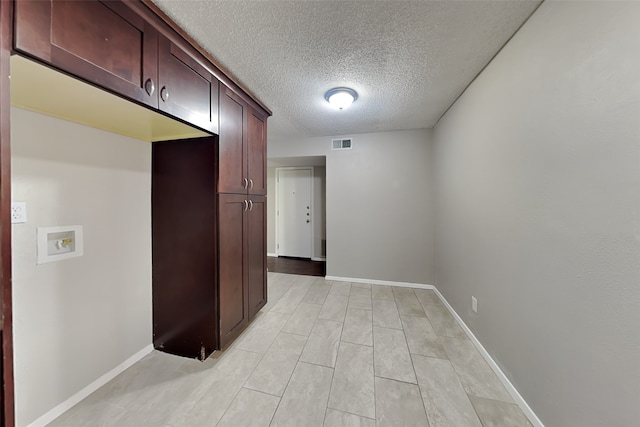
<box><xmin>158</xmin><ymin>36</ymin><xmax>219</xmax><ymax>134</ymax></box>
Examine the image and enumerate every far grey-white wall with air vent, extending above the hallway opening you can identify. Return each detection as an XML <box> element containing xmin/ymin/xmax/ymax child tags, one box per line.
<box><xmin>267</xmin><ymin>130</ymin><xmax>433</xmax><ymax>284</ymax></box>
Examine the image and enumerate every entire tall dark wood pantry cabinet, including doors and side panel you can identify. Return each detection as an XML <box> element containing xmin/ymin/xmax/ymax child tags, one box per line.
<box><xmin>152</xmin><ymin>91</ymin><xmax>267</xmax><ymax>358</ymax></box>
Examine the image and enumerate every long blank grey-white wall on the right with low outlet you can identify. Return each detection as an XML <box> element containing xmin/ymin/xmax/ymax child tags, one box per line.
<box><xmin>434</xmin><ymin>1</ymin><xmax>640</xmax><ymax>427</ymax></box>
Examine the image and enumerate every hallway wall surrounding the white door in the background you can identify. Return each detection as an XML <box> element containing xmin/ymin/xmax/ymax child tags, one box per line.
<box><xmin>267</xmin><ymin>165</ymin><xmax>326</xmax><ymax>259</ymax></box>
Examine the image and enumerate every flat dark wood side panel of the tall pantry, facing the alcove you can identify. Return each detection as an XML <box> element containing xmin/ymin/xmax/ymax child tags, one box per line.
<box><xmin>151</xmin><ymin>137</ymin><xmax>218</xmax><ymax>357</ymax></box>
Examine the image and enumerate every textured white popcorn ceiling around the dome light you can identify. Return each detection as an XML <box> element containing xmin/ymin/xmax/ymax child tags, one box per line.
<box><xmin>153</xmin><ymin>0</ymin><xmax>540</xmax><ymax>138</ymax></box>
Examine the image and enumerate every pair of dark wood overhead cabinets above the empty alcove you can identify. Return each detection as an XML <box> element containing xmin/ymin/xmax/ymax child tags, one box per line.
<box><xmin>14</xmin><ymin>0</ymin><xmax>224</xmax><ymax>134</ymax></box>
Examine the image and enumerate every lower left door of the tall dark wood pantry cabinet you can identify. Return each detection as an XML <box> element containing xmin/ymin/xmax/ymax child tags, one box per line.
<box><xmin>218</xmin><ymin>194</ymin><xmax>248</xmax><ymax>348</ymax></box>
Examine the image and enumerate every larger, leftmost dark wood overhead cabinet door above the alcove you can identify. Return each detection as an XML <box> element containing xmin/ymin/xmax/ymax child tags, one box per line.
<box><xmin>15</xmin><ymin>0</ymin><xmax>158</xmax><ymax>108</ymax></box>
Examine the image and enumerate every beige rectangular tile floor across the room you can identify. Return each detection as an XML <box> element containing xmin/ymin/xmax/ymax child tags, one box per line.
<box><xmin>50</xmin><ymin>273</ymin><xmax>531</xmax><ymax>427</ymax></box>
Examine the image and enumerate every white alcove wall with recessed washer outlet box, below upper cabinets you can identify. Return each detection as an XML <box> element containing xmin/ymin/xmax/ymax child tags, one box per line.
<box><xmin>11</xmin><ymin>108</ymin><xmax>152</xmax><ymax>427</ymax></box>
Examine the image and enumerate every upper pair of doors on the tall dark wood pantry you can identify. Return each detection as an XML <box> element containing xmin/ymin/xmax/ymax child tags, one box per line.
<box><xmin>218</xmin><ymin>87</ymin><xmax>267</xmax><ymax>195</ymax></box>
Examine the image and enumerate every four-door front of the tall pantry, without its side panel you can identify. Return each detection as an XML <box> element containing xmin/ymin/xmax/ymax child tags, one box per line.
<box><xmin>218</xmin><ymin>88</ymin><xmax>267</xmax><ymax>345</ymax></box>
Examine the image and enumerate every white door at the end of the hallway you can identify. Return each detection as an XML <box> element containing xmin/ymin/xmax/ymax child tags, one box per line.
<box><xmin>276</xmin><ymin>168</ymin><xmax>313</xmax><ymax>258</ymax></box>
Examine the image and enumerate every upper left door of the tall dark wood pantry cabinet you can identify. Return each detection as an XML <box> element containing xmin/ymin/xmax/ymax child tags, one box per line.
<box><xmin>218</xmin><ymin>86</ymin><xmax>248</xmax><ymax>194</ymax></box>
